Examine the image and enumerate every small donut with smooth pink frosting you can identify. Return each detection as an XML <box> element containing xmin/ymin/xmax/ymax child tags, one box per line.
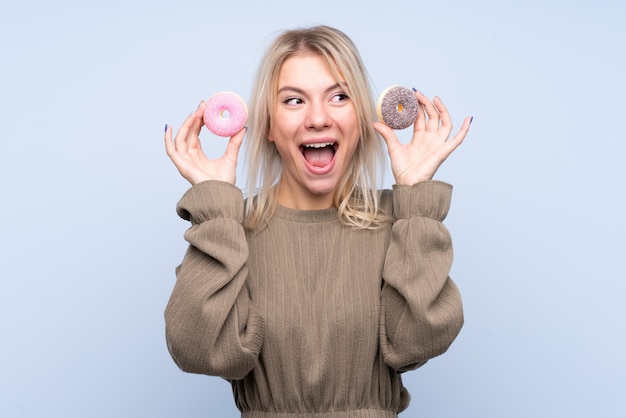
<box><xmin>203</xmin><ymin>91</ymin><xmax>248</xmax><ymax>136</ymax></box>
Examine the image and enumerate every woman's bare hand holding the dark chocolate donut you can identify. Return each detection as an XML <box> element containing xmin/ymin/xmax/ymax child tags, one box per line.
<box><xmin>374</xmin><ymin>92</ymin><xmax>471</xmax><ymax>185</ymax></box>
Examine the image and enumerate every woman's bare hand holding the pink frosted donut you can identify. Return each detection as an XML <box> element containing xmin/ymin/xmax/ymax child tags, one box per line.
<box><xmin>165</xmin><ymin>101</ymin><xmax>246</xmax><ymax>185</ymax></box>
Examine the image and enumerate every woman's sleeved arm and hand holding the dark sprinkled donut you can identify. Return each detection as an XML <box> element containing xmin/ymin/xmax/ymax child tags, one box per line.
<box><xmin>374</xmin><ymin>91</ymin><xmax>472</xmax><ymax>371</ymax></box>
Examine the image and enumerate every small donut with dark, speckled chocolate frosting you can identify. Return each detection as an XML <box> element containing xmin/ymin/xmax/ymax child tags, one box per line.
<box><xmin>376</xmin><ymin>86</ymin><xmax>419</xmax><ymax>129</ymax></box>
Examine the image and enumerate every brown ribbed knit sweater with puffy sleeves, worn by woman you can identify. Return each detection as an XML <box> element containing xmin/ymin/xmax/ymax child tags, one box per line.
<box><xmin>165</xmin><ymin>181</ymin><xmax>463</xmax><ymax>418</ymax></box>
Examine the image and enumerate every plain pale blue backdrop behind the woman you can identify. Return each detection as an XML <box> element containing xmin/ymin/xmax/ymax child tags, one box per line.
<box><xmin>0</xmin><ymin>0</ymin><xmax>626</xmax><ymax>418</ymax></box>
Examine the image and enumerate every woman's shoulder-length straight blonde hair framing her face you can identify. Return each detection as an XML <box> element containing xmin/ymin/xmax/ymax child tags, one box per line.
<box><xmin>246</xmin><ymin>26</ymin><xmax>388</xmax><ymax>229</ymax></box>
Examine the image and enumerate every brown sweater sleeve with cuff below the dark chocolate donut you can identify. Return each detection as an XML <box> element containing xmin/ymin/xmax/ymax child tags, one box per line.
<box><xmin>380</xmin><ymin>181</ymin><xmax>463</xmax><ymax>371</ymax></box>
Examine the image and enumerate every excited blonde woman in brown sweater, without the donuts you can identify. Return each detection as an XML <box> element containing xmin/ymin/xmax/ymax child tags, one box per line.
<box><xmin>165</xmin><ymin>26</ymin><xmax>470</xmax><ymax>418</ymax></box>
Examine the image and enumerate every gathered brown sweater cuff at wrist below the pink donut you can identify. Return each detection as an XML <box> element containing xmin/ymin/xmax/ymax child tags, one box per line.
<box><xmin>176</xmin><ymin>180</ymin><xmax>244</xmax><ymax>224</ymax></box>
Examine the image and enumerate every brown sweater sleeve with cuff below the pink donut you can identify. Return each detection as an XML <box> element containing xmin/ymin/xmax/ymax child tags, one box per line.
<box><xmin>165</xmin><ymin>181</ymin><xmax>263</xmax><ymax>379</ymax></box>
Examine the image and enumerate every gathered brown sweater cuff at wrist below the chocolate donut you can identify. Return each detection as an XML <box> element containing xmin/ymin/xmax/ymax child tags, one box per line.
<box><xmin>393</xmin><ymin>180</ymin><xmax>452</xmax><ymax>222</ymax></box>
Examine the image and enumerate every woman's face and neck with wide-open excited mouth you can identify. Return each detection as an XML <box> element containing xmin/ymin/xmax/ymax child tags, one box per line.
<box><xmin>268</xmin><ymin>53</ymin><xmax>359</xmax><ymax>209</ymax></box>
